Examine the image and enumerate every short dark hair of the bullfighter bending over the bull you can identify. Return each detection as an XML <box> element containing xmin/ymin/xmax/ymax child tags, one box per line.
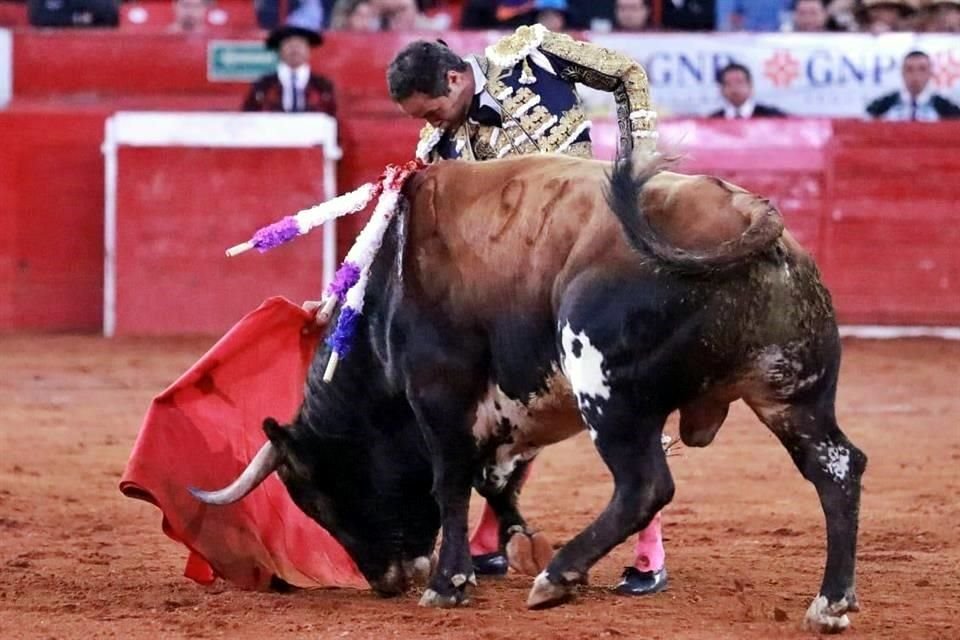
<box><xmin>387</xmin><ymin>40</ymin><xmax>468</xmax><ymax>102</ymax></box>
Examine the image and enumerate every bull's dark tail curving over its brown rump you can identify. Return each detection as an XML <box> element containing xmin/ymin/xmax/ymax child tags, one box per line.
<box><xmin>607</xmin><ymin>156</ymin><xmax>783</xmax><ymax>275</ymax></box>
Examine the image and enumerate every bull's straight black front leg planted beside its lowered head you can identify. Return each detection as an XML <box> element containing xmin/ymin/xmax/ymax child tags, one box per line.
<box><xmin>409</xmin><ymin>382</ymin><xmax>477</xmax><ymax>607</ymax></box>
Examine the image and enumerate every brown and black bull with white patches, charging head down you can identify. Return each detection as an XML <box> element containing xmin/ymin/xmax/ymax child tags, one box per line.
<box><xmin>191</xmin><ymin>156</ymin><xmax>867</xmax><ymax>631</ymax></box>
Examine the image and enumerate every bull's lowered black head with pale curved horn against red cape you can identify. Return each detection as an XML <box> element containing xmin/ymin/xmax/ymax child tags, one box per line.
<box><xmin>191</xmin><ymin>410</ymin><xmax>440</xmax><ymax>596</ymax></box>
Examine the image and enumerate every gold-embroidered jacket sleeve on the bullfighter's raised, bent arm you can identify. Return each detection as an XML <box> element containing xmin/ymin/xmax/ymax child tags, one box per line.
<box><xmin>540</xmin><ymin>32</ymin><xmax>656</xmax><ymax>153</ymax></box>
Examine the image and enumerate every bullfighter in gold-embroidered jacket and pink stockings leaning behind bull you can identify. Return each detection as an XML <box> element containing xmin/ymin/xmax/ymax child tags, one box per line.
<box><xmin>387</xmin><ymin>24</ymin><xmax>667</xmax><ymax>595</ymax></box>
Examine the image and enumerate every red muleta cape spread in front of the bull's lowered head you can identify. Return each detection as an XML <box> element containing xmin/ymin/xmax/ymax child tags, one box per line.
<box><xmin>120</xmin><ymin>298</ymin><xmax>367</xmax><ymax>589</ymax></box>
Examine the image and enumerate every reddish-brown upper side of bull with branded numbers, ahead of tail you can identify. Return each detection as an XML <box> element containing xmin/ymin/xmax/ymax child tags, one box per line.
<box><xmin>408</xmin><ymin>155</ymin><xmax>632</xmax><ymax>316</ymax></box>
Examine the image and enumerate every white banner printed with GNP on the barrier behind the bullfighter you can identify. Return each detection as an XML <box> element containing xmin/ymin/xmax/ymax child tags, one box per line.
<box><xmin>588</xmin><ymin>33</ymin><xmax>960</xmax><ymax>117</ymax></box>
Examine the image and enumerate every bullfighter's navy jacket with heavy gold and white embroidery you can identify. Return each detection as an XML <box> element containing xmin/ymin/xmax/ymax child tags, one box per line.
<box><xmin>417</xmin><ymin>25</ymin><xmax>657</xmax><ymax>162</ymax></box>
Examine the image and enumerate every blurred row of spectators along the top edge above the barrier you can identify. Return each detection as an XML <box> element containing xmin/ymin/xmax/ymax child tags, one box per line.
<box><xmin>15</xmin><ymin>0</ymin><xmax>960</xmax><ymax>34</ymax></box>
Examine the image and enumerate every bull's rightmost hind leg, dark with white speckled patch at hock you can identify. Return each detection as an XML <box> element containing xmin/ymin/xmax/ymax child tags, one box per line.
<box><xmin>746</xmin><ymin>377</ymin><xmax>867</xmax><ymax>633</ymax></box>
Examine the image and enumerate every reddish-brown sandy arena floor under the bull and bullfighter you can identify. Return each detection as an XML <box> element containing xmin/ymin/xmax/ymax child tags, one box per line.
<box><xmin>0</xmin><ymin>336</ymin><xmax>960</xmax><ymax>640</ymax></box>
